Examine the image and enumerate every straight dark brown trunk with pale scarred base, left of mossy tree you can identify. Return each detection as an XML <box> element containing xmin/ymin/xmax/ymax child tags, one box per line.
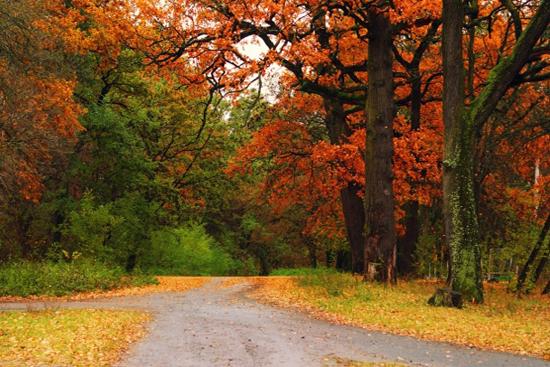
<box><xmin>365</xmin><ymin>6</ymin><xmax>396</xmax><ymax>283</ymax></box>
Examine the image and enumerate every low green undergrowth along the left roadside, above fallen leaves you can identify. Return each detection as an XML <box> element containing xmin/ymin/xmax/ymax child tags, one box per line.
<box><xmin>0</xmin><ymin>259</ymin><xmax>155</xmax><ymax>297</ymax></box>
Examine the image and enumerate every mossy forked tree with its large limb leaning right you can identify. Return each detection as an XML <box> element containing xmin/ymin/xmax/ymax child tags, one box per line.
<box><xmin>443</xmin><ymin>0</ymin><xmax>550</xmax><ymax>302</ymax></box>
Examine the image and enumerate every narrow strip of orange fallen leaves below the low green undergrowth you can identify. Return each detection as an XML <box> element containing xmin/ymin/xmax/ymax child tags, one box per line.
<box><xmin>0</xmin><ymin>276</ymin><xmax>210</xmax><ymax>302</ymax></box>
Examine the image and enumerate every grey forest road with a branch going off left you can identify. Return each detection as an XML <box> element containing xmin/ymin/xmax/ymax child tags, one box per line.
<box><xmin>0</xmin><ymin>278</ymin><xmax>550</xmax><ymax>367</ymax></box>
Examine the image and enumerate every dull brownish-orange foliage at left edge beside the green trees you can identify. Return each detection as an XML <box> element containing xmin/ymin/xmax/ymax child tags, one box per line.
<box><xmin>0</xmin><ymin>1</ymin><xmax>84</xmax><ymax>202</ymax></box>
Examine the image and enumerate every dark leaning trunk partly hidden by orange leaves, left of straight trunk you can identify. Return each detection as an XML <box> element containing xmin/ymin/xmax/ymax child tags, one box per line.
<box><xmin>324</xmin><ymin>98</ymin><xmax>365</xmax><ymax>274</ymax></box>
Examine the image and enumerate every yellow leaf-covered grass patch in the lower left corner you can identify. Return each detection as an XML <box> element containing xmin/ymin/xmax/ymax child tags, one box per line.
<box><xmin>0</xmin><ymin>310</ymin><xmax>150</xmax><ymax>367</ymax></box>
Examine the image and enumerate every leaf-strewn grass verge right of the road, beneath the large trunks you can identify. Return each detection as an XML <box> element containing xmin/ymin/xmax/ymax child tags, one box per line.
<box><xmin>251</xmin><ymin>270</ymin><xmax>550</xmax><ymax>359</ymax></box>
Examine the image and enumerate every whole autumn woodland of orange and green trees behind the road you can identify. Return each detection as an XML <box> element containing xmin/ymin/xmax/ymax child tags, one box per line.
<box><xmin>0</xmin><ymin>0</ymin><xmax>550</xmax><ymax>307</ymax></box>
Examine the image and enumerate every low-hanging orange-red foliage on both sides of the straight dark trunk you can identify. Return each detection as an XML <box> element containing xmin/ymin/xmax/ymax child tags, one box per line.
<box><xmin>227</xmin><ymin>107</ymin><xmax>443</xmax><ymax>236</ymax></box>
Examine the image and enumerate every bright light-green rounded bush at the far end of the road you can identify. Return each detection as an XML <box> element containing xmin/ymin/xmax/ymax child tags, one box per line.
<box><xmin>141</xmin><ymin>224</ymin><xmax>240</xmax><ymax>275</ymax></box>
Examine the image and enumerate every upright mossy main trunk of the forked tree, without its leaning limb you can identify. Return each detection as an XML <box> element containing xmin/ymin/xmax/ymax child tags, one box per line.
<box><xmin>443</xmin><ymin>0</ymin><xmax>483</xmax><ymax>302</ymax></box>
